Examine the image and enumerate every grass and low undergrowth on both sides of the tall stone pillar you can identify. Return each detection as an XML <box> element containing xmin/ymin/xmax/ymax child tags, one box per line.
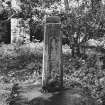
<box><xmin>0</xmin><ymin>43</ymin><xmax>105</xmax><ymax>105</ymax></box>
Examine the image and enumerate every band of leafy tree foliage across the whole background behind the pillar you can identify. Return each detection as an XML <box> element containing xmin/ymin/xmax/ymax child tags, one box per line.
<box><xmin>0</xmin><ymin>0</ymin><xmax>105</xmax><ymax>56</ymax></box>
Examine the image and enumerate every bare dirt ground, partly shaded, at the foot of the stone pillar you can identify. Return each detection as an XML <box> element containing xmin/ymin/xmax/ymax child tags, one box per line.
<box><xmin>6</xmin><ymin>84</ymin><xmax>96</xmax><ymax>105</ymax></box>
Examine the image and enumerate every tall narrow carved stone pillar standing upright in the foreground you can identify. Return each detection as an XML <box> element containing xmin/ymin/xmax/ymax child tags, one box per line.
<box><xmin>42</xmin><ymin>16</ymin><xmax>63</xmax><ymax>86</ymax></box>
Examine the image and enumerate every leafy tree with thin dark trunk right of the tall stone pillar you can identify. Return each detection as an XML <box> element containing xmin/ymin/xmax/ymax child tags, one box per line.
<box><xmin>63</xmin><ymin>0</ymin><xmax>105</xmax><ymax>56</ymax></box>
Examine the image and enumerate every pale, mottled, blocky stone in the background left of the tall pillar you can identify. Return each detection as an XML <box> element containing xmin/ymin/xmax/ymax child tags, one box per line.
<box><xmin>11</xmin><ymin>18</ymin><xmax>30</xmax><ymax>43</ymax></box>
